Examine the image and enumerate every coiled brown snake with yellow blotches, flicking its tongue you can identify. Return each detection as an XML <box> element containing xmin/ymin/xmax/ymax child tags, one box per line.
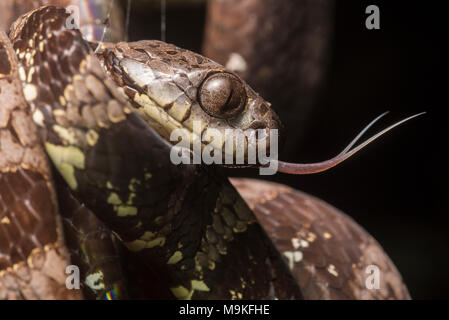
<box><xmin>0</xmin><ymin>1</ymin><xmax>414</xmax><ymax>299</ymax></box>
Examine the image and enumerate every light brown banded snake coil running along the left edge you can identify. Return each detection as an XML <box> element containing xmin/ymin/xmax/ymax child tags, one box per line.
<box><xmin>0</xmin><ymin>32</ymin><xmax>81</xmax><ymax>299</ymax></box>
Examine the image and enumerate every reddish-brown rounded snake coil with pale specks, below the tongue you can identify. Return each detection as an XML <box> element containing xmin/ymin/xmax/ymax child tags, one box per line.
<box><xmin>231</xmin><ymin>179</ymin><xmax>410</xmax><ymax>300</ymax></box>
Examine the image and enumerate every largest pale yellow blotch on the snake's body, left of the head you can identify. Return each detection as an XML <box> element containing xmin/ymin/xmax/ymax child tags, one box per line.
<box><xmin>45</xmin><ymin>142</ymin><xmax>85</xmax><ymax>190</ymax></box>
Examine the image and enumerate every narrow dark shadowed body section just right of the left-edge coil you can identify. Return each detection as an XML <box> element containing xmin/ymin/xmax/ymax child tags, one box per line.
<box><xmin>55</xmin><ymin>173</ymin><xmax>129</xmax><ymax>300</ymax></box>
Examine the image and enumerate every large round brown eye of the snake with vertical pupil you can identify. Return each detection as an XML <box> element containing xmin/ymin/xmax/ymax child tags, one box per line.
<box><xmin>198</xmin><ymin>73</ymin><xmax>246</xmax><ymax>119</ymax></box>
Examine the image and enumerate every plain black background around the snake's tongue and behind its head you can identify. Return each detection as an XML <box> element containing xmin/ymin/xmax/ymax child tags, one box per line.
<box><xmin>124</xmin><ymin>0</ymin><xmax>449</xmax><ymax>299</ymax></box>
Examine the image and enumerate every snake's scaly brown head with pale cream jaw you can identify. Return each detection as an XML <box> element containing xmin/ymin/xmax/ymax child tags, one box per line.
<box><xmin>98</xmin><ymin>41</ymin><xmax>281</xmax><ymax>166</ymax></box>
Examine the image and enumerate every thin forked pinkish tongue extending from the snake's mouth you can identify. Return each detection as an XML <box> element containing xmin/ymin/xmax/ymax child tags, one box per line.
<box><xmin>272</xmin><ymin>112</ymin><xmax>425</xmax><ymax>174</ymax></box>
